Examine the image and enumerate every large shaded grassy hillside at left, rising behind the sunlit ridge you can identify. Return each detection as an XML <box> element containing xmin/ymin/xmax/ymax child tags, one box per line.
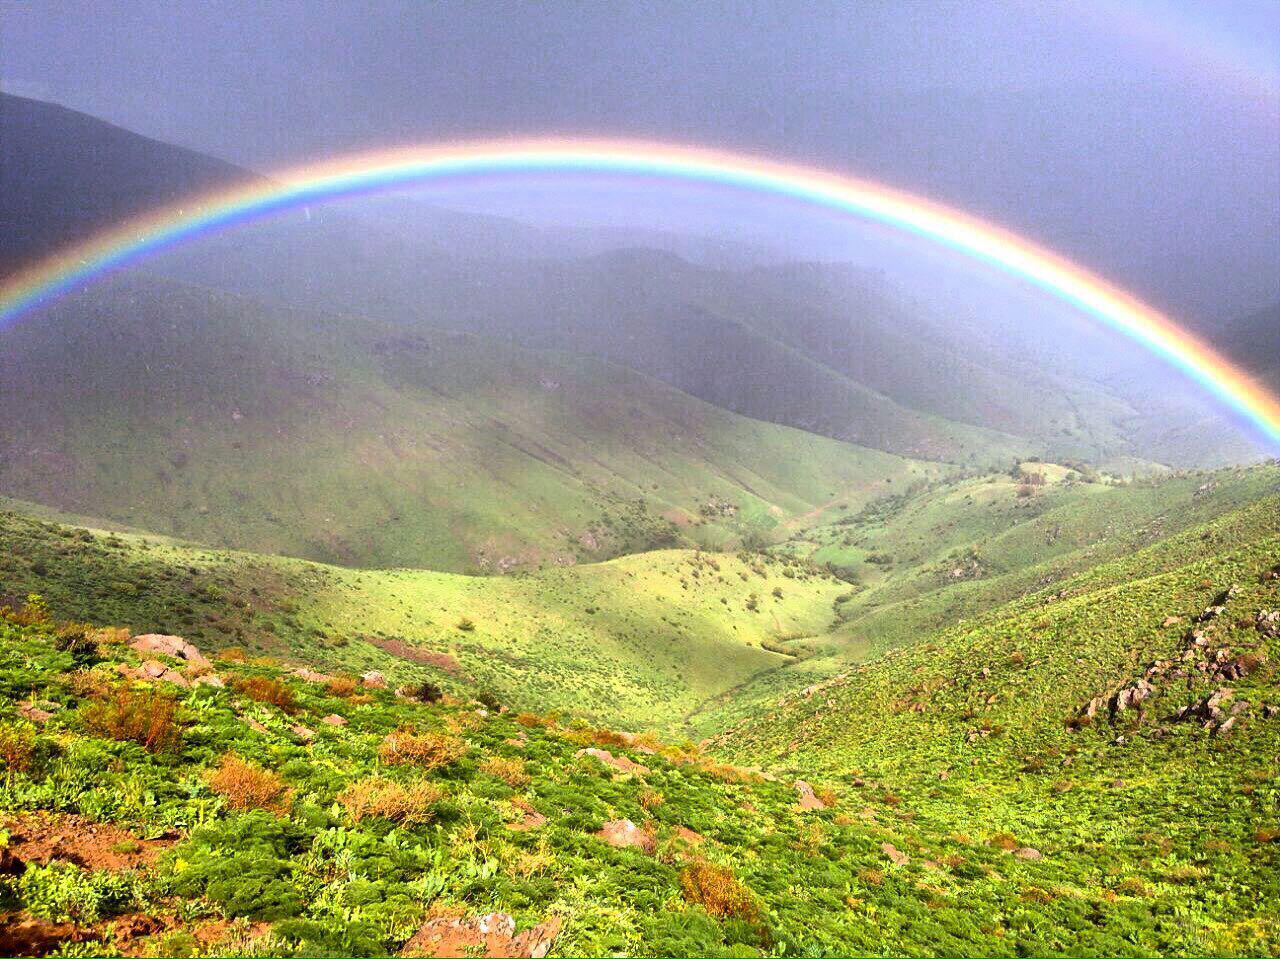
<box><xmin>0</xmin><ymin>278</ymin><xmax>940</xmax><ymax>571</ymax></box>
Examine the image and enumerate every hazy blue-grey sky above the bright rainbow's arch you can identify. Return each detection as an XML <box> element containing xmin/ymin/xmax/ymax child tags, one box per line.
<box><xmin>0</xmin><ymin>0</ymin><xmax>1280</xmax><ymax>318</ymax></box>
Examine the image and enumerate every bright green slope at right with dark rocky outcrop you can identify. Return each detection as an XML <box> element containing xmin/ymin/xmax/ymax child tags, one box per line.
<box><xmin>716</xmin><ymin>496</ymin><xmax>1280</xmax><ymax>955</ymax></box>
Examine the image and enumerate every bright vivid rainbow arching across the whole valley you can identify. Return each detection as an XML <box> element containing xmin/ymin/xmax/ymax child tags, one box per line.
<box><xmin>0</xmin><ymin>140</ymin><xmax>1280</xmax><ymax>447</ymax></box>
